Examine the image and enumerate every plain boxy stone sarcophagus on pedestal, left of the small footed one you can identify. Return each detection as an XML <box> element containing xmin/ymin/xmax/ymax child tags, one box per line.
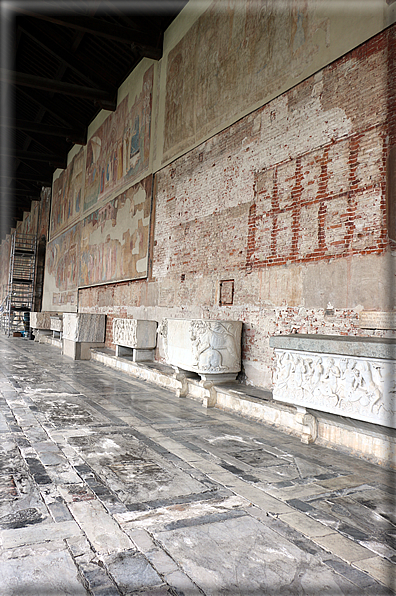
<box><xmin>62</xmin><ymin>313</ymin><xmax>106</xmax><ymax>360</ymax></box>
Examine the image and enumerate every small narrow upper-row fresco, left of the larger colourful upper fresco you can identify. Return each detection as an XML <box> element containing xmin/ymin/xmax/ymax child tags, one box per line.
<box><xmin>50</xmin><ymin>147</ymin><xmax>85</xmax><ymax>237</ymax></box>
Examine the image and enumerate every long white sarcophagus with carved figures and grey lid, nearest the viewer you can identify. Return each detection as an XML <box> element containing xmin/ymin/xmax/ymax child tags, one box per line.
<box><xmin>270</xmin><ymin>334</ymin><xmax>396</xmax><ymax>428</ymax></box>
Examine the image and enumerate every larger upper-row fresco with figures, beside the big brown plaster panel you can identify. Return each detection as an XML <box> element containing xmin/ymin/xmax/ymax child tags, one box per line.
<box><xmin>84</xmin><ymin>66</ymin><xmax>154</xmax><ymax>211</ymax></box>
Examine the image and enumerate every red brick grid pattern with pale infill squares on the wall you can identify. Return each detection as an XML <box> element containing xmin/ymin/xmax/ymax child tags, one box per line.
<box><xmin>247</xmin><ymin>124</ymin><xmax>388</xmax><ymax>266</ymax></box>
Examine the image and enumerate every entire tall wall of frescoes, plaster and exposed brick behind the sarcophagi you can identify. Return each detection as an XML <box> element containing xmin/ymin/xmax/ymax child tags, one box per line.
<box><xmin>24</xmin><ymin>0</ymin><xmax>395</xmax><ymax>387</ymax></box>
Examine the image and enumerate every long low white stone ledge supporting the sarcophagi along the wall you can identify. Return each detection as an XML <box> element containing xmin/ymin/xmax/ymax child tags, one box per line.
<box><xmin>91</xmin><ymin>349</ymin><xmax>396</xmax><ymax>469</ymax></box>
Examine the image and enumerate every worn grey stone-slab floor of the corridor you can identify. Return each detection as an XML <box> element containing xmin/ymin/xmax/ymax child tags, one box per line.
<box><xmin>0</xmin><ymin>336</ymin><xmax>396</xmax><ymax>596</ymax></box>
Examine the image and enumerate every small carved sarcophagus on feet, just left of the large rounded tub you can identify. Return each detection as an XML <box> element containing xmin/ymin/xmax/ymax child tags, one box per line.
<box><xmin>113</xmin><ymin>319</ymin><xmax>157</xmax><ymax>362</ymax></box>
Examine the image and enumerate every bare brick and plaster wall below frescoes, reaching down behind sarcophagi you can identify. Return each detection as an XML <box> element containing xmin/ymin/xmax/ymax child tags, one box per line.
<box><xmin>79</xmin><ymin>27</ymin><xmax>396</xmax><ymax>387</ymax></box>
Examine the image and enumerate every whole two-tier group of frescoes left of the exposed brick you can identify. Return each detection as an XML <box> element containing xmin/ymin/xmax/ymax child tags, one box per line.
<box><xmin>42</xmin><ymin>61</ymin><xmax>154</xmax><ymax>312</ymax></box>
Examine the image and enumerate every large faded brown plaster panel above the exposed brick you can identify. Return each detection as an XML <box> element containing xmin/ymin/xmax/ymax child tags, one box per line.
<box><xmin>154</xmin><ymin>0</ymin><xmax>396</xmax><ymax>170</ymax></box>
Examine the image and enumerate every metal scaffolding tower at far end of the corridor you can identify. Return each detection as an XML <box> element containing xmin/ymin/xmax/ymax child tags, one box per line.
<box><xmin>1</xmin><ymin>232</ymin><xmax>37</xmax><ymax>336</ymax></box>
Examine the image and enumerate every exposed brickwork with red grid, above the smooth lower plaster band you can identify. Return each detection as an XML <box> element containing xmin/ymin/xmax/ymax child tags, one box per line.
<box><xmin>153</xmin><ymin>29</ymin><xmax>394</xmax><ymax>278</ymax></box>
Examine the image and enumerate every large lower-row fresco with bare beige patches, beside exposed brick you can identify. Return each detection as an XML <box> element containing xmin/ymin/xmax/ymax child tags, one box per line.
<box><xmin>79</xmin><ymin>176</ymin><xmax>152</xmax><ymax>286</ymax></box>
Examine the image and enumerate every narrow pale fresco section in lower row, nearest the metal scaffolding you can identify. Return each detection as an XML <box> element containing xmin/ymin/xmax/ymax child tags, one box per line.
<box><xmin>42</xmin><ymin>222</ymin><xmax>82</xmax><ymax>311</ymax></box>
